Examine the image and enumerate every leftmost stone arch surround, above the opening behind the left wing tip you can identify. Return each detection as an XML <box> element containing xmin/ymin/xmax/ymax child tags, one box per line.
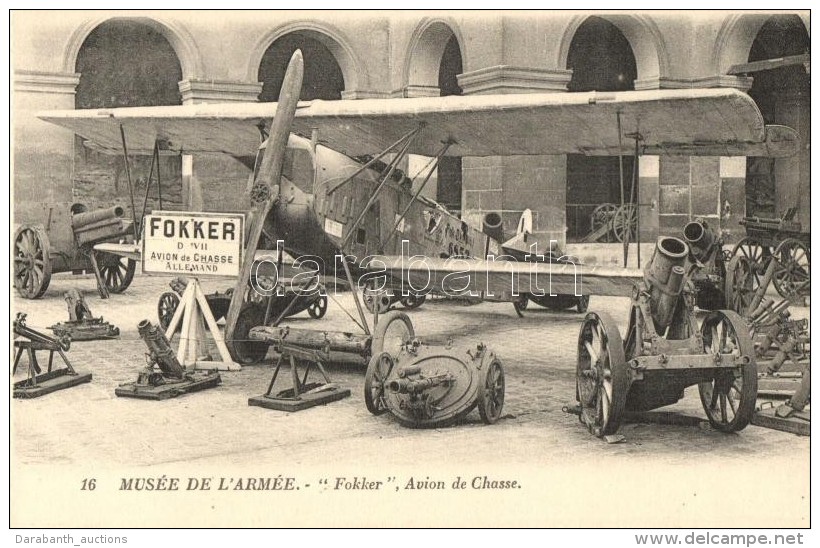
<box><xmin>63</xmin><ymin>17</ymin><xmax>203</xmax><ymax>79</ymax></box>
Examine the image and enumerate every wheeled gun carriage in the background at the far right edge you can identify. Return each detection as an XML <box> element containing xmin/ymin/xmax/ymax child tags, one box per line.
<box><xmin>732</xmin><ymin>207</ymin><xmax>811</xmax><ymax>298</ymax></box>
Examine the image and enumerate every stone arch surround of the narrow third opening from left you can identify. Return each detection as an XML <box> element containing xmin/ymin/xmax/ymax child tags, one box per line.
<box><xmin>401</xmin><ymin>18</ymin><xmax>468</xmax><ymax>93</ymax></box>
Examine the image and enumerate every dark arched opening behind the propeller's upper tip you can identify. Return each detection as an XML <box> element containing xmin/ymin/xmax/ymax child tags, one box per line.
<box><xmin>259</xmin><ymin>31</ymin><xmax>345</xmax><ymax>102</ymax></box>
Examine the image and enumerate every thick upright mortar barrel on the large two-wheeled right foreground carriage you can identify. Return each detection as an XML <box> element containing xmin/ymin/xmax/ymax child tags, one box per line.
<box><xmin>644</xmin><ymin>237</ymin><xmax>689</xmax><ymax>334</ymax></box>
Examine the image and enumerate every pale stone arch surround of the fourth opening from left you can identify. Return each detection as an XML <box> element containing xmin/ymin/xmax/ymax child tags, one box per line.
<box><xmin>555</xmin><ymin>13</ymin><xmax>669</xmax><ymax>85</ymax></box>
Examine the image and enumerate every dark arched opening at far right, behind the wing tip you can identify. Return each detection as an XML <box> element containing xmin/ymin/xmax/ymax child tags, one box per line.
<box><xmin>746</xmin><ymin>15</ymin><xmax>811</xmax><ymax>220</ymax></box>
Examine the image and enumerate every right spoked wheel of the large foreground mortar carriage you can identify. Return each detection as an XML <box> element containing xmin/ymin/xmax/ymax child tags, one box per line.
<box><xmin>698</xmin><ymin>310</ymin><xmax>757</xmax><ymax>432</ymax></box>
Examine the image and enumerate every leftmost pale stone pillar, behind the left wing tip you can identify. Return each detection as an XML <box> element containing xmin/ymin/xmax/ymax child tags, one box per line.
<box><xmin>12</xmin><ymin>70</ymin><xmax>80</xmax><ymax>249</ymax></box>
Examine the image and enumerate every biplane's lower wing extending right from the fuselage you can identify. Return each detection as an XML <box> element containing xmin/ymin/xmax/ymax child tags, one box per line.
<box><xmin>364</xmin><ymin>256</ymin><xmax>643</xmax><ymax>298</ymax></box>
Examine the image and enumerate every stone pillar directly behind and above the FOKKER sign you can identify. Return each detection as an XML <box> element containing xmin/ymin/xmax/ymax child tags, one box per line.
<box><xmin>179</xmin><ymin>78</ymin><xmax>262</xmax><ymax>212</ymax></box>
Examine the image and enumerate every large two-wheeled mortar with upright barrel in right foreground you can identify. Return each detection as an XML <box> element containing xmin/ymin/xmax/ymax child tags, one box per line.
<box><xmin>576</xmin><ymin>237</ymin><xmax>757</xmax><ymax>437</ymax></box>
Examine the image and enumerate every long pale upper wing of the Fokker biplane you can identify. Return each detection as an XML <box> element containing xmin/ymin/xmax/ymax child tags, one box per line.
<box><xmin>40</xmin><ymin>88</ymin><xmax>799</xmax><ymax>157</ymax></box>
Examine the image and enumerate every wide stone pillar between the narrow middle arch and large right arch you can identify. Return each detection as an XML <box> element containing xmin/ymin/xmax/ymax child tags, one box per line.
<box><xmin>458</xmin><ymin>65</ymin><xmax>572</xmax><ymax>249</ymax></box>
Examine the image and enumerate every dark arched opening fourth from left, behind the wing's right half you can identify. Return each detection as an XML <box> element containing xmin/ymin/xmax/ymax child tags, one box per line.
<box><xmin>564</xmin><ymin>16</ymin><xmax>638</xmax><ymax>242</ymax></box>
